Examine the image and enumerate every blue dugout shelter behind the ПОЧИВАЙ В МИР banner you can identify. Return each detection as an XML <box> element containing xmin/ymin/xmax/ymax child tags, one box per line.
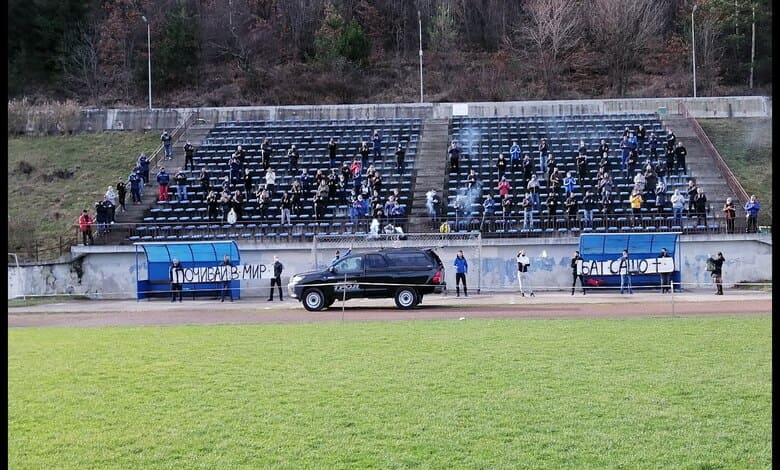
<box><xmin>134</xmin><ymin>241</ymin><xmax>241</xmax><ymax>300</ymax></box>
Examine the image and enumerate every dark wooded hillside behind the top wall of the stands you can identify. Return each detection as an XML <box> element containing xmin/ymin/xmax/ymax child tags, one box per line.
<box><xmin>8</xmin><ymin>0</ymin><xmax>772</xmax><ymax>107</ymax></box>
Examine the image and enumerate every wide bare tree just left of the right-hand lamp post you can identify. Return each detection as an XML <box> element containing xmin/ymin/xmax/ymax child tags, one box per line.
<box><xmin>585</xmin><ymin>0</ymin><xmax>668</xmax><ymax>96</ymax></box>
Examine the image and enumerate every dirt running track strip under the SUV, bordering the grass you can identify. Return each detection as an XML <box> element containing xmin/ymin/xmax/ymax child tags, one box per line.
<box><xmin>8</xmin><ymin>291</ymin><xmax>772</xmax><ymax>327</ymax></box>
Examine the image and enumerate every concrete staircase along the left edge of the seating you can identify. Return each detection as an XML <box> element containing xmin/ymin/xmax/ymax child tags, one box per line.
<box><xmin>100</xmin><ymin>124</ymin><xmax>214</xmax><ymax>245</ymax></box>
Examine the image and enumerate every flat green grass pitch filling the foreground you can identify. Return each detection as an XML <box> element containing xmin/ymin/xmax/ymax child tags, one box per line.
<box><xmin>8</xmin><ymin>316</ymin><xmax>772</xmax><ymax>469</ymax></box>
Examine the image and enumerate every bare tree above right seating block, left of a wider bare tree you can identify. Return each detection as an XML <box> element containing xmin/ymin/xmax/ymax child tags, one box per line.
<box><xmin>508</xmin><ymin>0</ymin><xmax>583</xmax><ymax>97</ymax></box>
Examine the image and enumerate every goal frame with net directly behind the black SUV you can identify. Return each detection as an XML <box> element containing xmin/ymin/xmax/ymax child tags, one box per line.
<box><xmin>311</xmin><ymin>231</ymin><xmax>482</xmax><ymax>293</ymax></box>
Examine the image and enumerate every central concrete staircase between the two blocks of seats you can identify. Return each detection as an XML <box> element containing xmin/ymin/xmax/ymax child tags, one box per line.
<box><xmin>407</xmin><ymin>118</ymin><xmax>450</xmax><ymax>233</ymax></box>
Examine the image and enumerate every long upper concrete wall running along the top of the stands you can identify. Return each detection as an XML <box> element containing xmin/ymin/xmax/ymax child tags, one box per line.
<box><xmin>76</xmin><ymin>96</ymin><xmax>772</xmax><ymax>132</ymax></box>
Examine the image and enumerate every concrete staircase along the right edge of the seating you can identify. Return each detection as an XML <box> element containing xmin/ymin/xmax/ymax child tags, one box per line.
<box><xmin>663</xmin><ymin>117</ymin><xmax>745</xmax><ymax>214</ymax></box>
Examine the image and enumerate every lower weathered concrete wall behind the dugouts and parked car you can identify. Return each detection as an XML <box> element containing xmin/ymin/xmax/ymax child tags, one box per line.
<box><xmin>8</xmin><ymin>234</ymin><xmax>772</xmax><ymax>299</ymax></box>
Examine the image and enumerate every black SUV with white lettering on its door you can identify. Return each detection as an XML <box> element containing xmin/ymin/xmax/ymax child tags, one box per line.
<box><xmin>287</xmin><ymin>248</ymin><xmax>447</xmax><ymax>312</ymax></box>
